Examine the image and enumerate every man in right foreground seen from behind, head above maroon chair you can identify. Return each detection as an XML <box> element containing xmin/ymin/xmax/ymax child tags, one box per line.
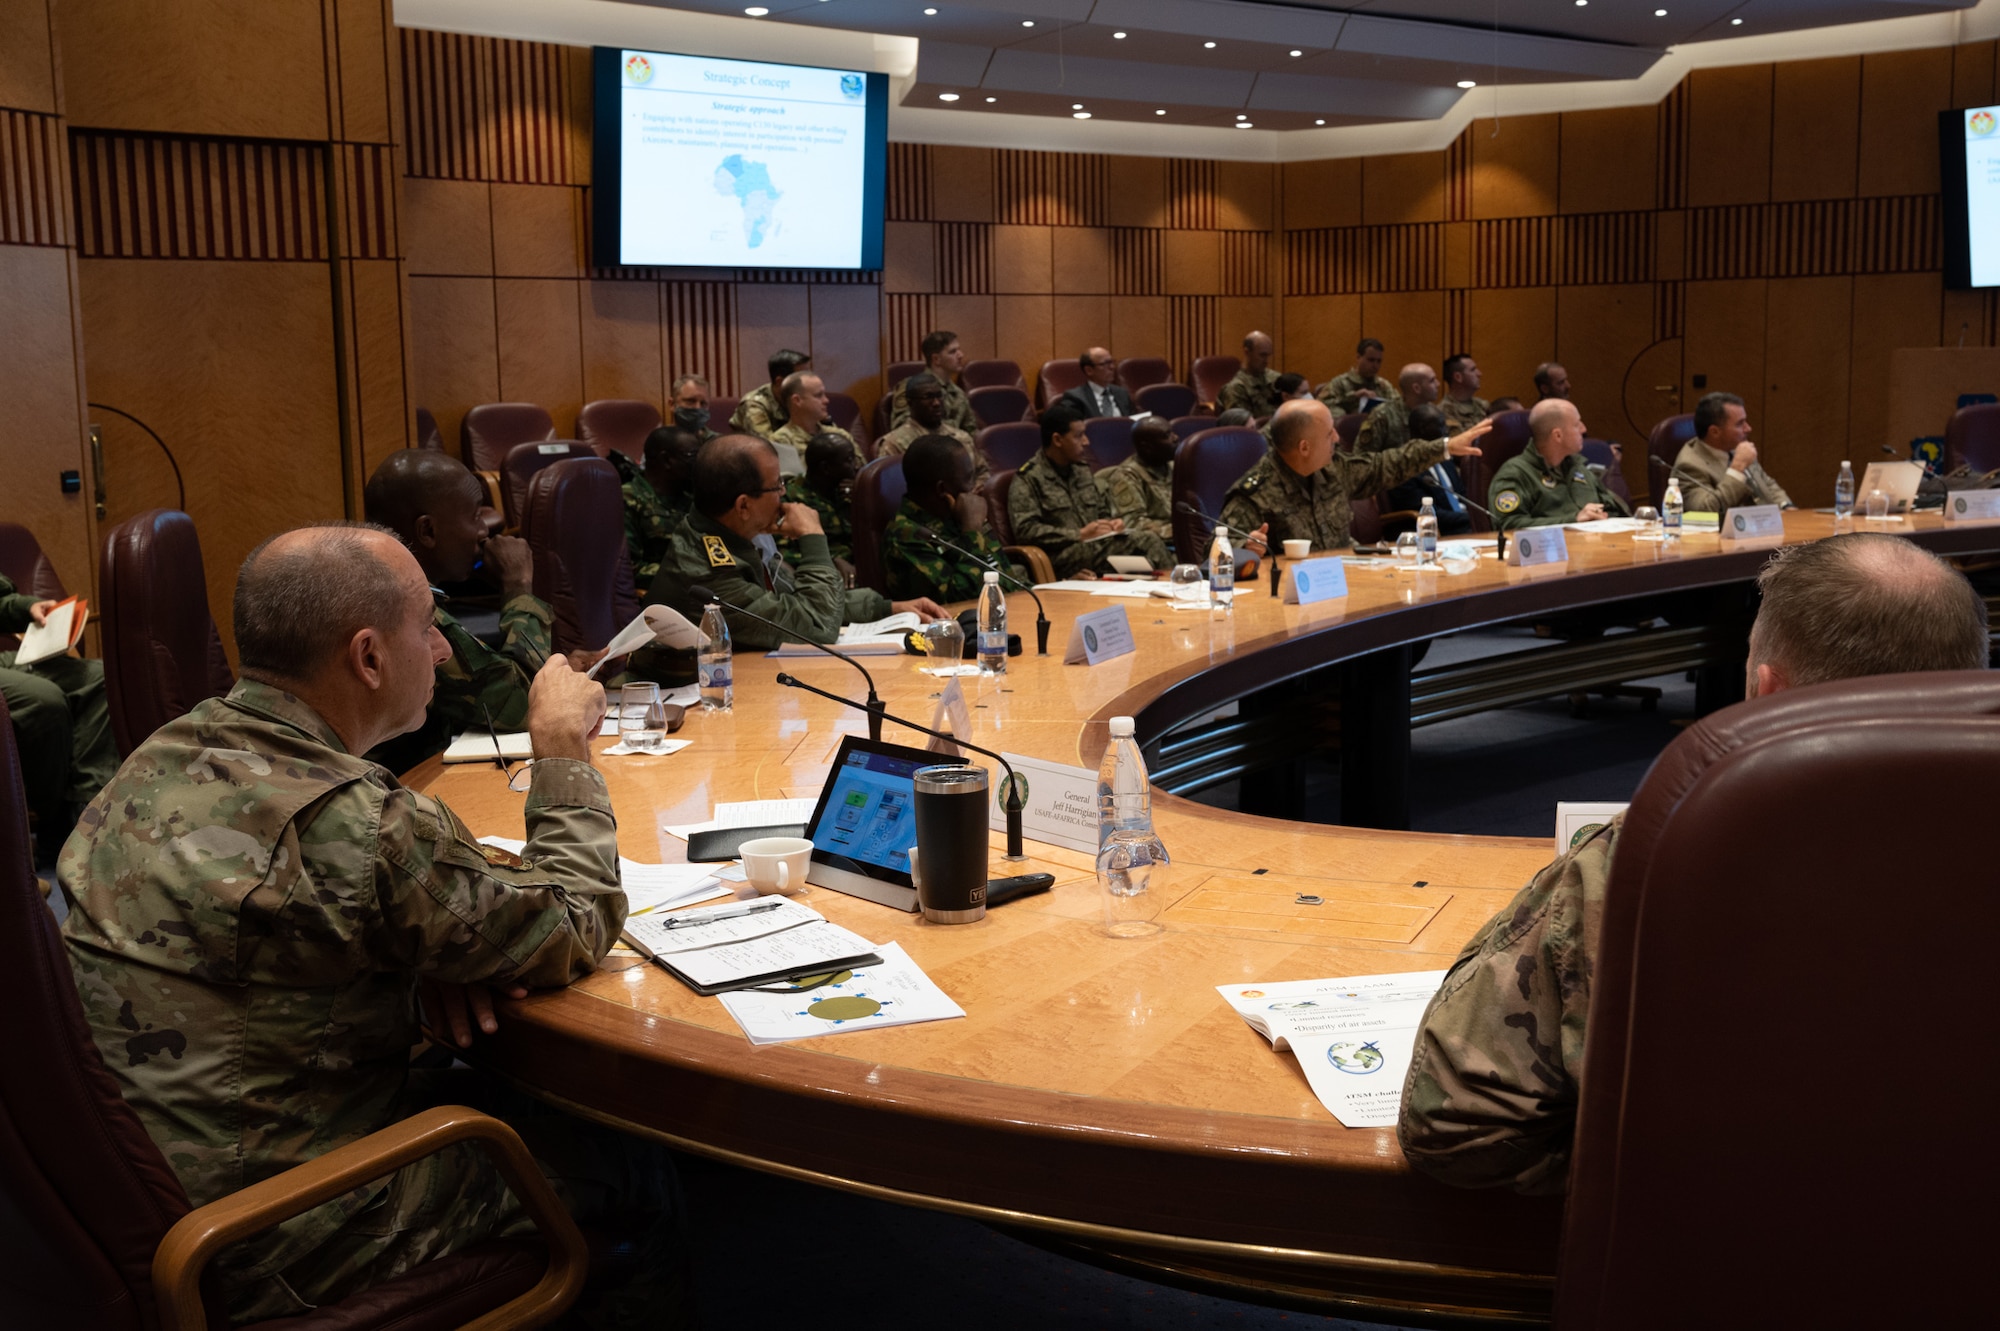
<box><xmin>1396</xmin><ymin>535</ymin><xmax>1986</xmax><ymax>1193</ymax></box>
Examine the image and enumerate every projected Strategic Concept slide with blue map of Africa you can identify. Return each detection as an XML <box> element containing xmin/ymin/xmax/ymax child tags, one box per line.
<box><xmin>618</xmin><ymin>50</ymin><xmax>868</xmax><ymax>268</ymax></box>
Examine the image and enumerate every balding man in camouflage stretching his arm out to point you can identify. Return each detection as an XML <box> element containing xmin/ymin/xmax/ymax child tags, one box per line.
<box><xmin>1222</xmin><ymin>400</ymin><xmax>1492</xmax><ymax>574</ymax></box>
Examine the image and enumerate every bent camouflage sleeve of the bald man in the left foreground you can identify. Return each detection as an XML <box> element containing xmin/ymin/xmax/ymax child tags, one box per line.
<box><xmin>376</xmin><ymin>757</ymin><xmax>626</xmax><ymax>985</ymax></box>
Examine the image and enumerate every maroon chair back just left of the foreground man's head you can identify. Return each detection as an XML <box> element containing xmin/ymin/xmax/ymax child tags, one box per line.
<box><xmin>98</xmin><ymin>508</ymin><xmax>236</xmax><ymax>755</ymax></box>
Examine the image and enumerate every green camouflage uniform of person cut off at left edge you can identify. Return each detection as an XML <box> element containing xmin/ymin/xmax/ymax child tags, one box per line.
<box><xmin>0</xmin><ymin>576</ymin><xmax>118</xmax><ymax>837</ymax></box>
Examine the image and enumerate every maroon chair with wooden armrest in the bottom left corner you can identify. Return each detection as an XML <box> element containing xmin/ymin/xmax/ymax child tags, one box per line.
<box><xmin>0</xmin><ymin>687</ymin><xmax>588</xmax><ymax>1331</ymax></box>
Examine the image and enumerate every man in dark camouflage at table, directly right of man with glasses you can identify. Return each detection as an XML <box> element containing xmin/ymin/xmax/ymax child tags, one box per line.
<box><xmin>882</xmin><ymin>434</ymin><xmax>1028</xmax><ymax>602</ymax></box>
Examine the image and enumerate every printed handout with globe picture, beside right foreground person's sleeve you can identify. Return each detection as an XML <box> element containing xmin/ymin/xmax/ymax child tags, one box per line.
<box><xmin>1216</xmin><ymin>971</ymin><xmax>1444</xmax><ymax>1127</ymax></box>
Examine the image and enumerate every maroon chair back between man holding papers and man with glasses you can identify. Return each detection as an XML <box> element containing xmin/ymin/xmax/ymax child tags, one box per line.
<box><xmin>520</xmin><ymin>456</ymin><xmax>640</xmax><ymax>652</ymax></box>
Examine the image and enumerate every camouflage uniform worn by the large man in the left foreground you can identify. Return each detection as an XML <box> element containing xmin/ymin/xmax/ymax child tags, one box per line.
<box><xmin>60</xmin><ymin>679</ymin><xmax>626</xmax><ymax>1321</ymax></box>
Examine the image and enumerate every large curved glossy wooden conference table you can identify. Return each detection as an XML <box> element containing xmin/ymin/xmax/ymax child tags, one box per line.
<box><xmin>412</xmin><ymin>512</ymin><xmax>2000</xmax><ymax>1321</ymax></box>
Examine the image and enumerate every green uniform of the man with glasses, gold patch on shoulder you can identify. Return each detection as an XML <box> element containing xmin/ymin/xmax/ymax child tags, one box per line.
<box><xmin>660</xmin><ymin>514</ymin><xmax>892</xmax><ymax>652</ymax></box>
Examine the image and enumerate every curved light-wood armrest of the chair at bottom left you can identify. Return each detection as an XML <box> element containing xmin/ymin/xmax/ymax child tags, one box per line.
<box><xmin>152</xmin><ymin>1105</ymin><xmax>590</xmax><ymax>1331</ymax></box>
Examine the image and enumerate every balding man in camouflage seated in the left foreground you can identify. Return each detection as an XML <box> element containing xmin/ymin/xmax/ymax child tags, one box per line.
<box><xmin>60</xmin><ymin>523</ymin><xmax>674</xmax><ymax>1321</ymax></box>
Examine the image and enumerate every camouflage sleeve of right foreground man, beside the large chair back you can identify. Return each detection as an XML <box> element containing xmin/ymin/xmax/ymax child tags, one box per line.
<box><xmin>1396</xmin><ymin>813</ymin><xmax>1624</xmax><ymax>1193</ymax></box>
